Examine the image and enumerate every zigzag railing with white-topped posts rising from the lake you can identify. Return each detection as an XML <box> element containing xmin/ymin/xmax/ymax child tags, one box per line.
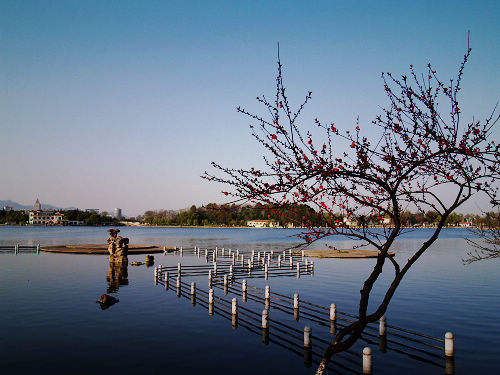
<box><xmin>154</xmin><ymin>247</ymin><xmax>454</xmax><ymax>374</ymax></box>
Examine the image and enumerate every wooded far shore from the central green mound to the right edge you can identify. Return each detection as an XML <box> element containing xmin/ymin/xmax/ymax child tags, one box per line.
<box><xmin>142</xmin><ymin>203</ymin><xmax>500</xmax><ymax>227</ymax></box>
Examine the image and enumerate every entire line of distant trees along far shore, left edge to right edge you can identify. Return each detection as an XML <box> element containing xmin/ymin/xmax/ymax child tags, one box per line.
<box><xmin>0</xmin><ymin>203</ymin><xmax>500</xmax><ymax>228</ymax></box>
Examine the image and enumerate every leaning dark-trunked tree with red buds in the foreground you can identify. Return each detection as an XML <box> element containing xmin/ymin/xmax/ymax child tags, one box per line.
<box><xmin>203</xmin><ymin>49</ymin><xmax>500</xmax><ymax>374</ymax></box>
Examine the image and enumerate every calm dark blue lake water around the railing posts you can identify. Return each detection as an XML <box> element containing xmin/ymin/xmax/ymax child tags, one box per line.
<box><xmin>0</xmin><ymin>226</ymin><xmax>500</xmax><ymax>374</ymax></box>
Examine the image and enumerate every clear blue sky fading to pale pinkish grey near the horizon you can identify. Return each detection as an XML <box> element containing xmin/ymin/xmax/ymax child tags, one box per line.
<box><xmin>0</xmin><ymin>0</ymin><xmax>500</xmax><ymax>216</ymax></box>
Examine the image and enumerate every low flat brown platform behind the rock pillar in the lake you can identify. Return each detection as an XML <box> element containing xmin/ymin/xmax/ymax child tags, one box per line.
<box><xmin>40</xmin><ymin>244</ymin><xmax>175</xmax><ymax>255</ymax></box>
